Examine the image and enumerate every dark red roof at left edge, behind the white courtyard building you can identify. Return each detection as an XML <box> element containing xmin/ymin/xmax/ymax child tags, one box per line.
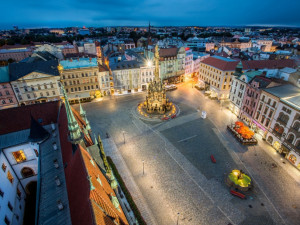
<box><xmin>0</xmin><ymin>101</ymin><xmax>60</xmax><ymax>135</ymax></box>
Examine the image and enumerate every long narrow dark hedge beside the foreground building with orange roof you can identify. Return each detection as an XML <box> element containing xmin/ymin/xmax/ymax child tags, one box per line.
<box><xmin>107</xmin><ymin>156</ymin><xmax>147</xmax><ymax>225</ymax></box>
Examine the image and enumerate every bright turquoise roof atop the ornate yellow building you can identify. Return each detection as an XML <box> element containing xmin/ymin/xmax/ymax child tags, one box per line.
<box><xmin>60</xmin><ymin>58</ymin><xmax>98</xmax><ymax>70</ymax></box>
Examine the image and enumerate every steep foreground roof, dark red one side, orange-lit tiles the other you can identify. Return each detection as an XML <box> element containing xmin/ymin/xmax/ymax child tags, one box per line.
<box><xmin>59</xmin><ymin>105</ymin><xmax>128</xmax><ymax>225</ymax></box>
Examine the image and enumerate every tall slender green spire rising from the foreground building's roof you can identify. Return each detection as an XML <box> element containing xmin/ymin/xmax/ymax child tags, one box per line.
<box><xmin>62</xmin><ymin>86</ymin><xmax>83</xmax><ymax>144</ymax></box>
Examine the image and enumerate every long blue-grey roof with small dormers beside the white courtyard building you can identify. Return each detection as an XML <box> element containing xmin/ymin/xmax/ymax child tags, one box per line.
<box><xmin>37</xmin><ymin>126</ymin><xmax>72</xmax><ymax>225</ymax></box>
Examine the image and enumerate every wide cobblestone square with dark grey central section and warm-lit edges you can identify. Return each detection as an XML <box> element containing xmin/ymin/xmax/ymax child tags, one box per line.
<box><xmin>75</xmin><ymin>84</ymin><xmax>300</xmax><ymax>225</ymax></box>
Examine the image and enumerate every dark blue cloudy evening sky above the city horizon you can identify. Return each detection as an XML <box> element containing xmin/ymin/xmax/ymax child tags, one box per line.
<box><xmin>0</xmin><ymin>0</ymin><xmax>300</xmax><ymax>29</ymax></box>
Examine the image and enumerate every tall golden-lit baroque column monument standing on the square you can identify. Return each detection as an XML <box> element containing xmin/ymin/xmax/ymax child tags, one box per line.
<box><xmin>143</xmin><ymin>45</ymin><xmax>172</xmax><ymax>114</ymax></box>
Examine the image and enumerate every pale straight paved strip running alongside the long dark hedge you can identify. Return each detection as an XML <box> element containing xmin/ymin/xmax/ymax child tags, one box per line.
<box><xmin>102</xmin><ymin>138</ymin><xmax>157</xmax><ymax>225</ymax></box>
